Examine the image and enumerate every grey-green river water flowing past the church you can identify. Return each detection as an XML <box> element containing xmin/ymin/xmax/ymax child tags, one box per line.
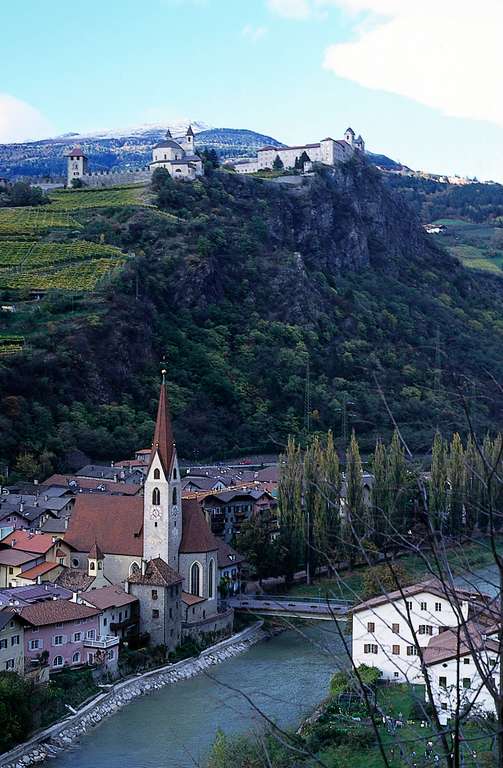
<box><xmin>47</xmin><ymin>622</ymin><xmax>347</xmax><ymax>768</ymax></box>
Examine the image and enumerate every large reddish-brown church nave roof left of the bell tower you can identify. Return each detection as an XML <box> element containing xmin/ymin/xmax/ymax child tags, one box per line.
<box><xmin>65</xmin><ymin>494</ymin><xmax>143</xmax><ymax>557</ymax></box>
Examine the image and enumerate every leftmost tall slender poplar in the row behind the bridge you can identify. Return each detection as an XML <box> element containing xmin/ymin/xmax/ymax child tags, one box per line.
<box><xmin>278</xmin><ymin>437</ymin><xmax>305</xmax><ymax>581</ymax></box>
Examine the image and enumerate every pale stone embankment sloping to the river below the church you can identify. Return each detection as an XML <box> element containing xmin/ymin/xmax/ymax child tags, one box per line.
<box><xmin>0</xmin><ymin>622</ymin><xmax>265</xmax><ymax>768</ymax></box>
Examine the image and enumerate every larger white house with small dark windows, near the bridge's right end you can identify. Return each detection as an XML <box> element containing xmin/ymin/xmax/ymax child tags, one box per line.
<box><xmin>352</xmin><ymin>579</ymin><xmax>490</xmax><ymax>683</ymax></box>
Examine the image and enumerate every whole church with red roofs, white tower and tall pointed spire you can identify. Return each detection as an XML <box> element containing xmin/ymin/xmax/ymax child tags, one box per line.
<box><xmin>65</xmin><ymin>371</ymin><xmax>233</xmax><ymax>650</ymax></box>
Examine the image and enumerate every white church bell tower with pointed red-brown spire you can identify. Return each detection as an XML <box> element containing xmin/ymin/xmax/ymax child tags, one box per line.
<box><xmin>143</xmin><ymin>370</ymin><xmax>182</xmax><ymax>570</ymax></box>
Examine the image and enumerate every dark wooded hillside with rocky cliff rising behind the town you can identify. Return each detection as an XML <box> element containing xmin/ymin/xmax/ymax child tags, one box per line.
<box><xmin>0</xmin><ymin>159</ymin><xmax>503</xmax><ymax>473</ymax></box>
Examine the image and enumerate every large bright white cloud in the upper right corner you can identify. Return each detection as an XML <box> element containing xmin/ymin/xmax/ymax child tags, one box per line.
<box><xmin>324</xmin><ymin>0</ymin><xmax>503</xmax><ymax>127</ymax></box>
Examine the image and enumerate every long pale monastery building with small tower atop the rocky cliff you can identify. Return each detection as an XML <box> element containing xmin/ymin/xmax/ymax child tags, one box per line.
<box><xmin>233</xmin><ymin>128</ymin><xmax>365</xmax><ymax>173</ymax></box>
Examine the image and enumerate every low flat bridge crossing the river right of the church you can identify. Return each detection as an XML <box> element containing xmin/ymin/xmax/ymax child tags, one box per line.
<box><xmin>228</xmin><ymin>595</ymin><xmax>351</xmax><ymax>621</ymax></box>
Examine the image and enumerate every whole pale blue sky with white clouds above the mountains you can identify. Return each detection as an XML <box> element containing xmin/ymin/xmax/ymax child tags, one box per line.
<box><xmin>0</xmin><ymin>0</ymin><xmax>503</xmax><ymax>182</ymax></box>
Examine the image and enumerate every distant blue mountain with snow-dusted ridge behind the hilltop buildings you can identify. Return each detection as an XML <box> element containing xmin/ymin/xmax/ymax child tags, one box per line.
<box><xmin>0</xmin><ymin>120</ymin><xmax>284</xmax><ymax>178</ymax></box>
